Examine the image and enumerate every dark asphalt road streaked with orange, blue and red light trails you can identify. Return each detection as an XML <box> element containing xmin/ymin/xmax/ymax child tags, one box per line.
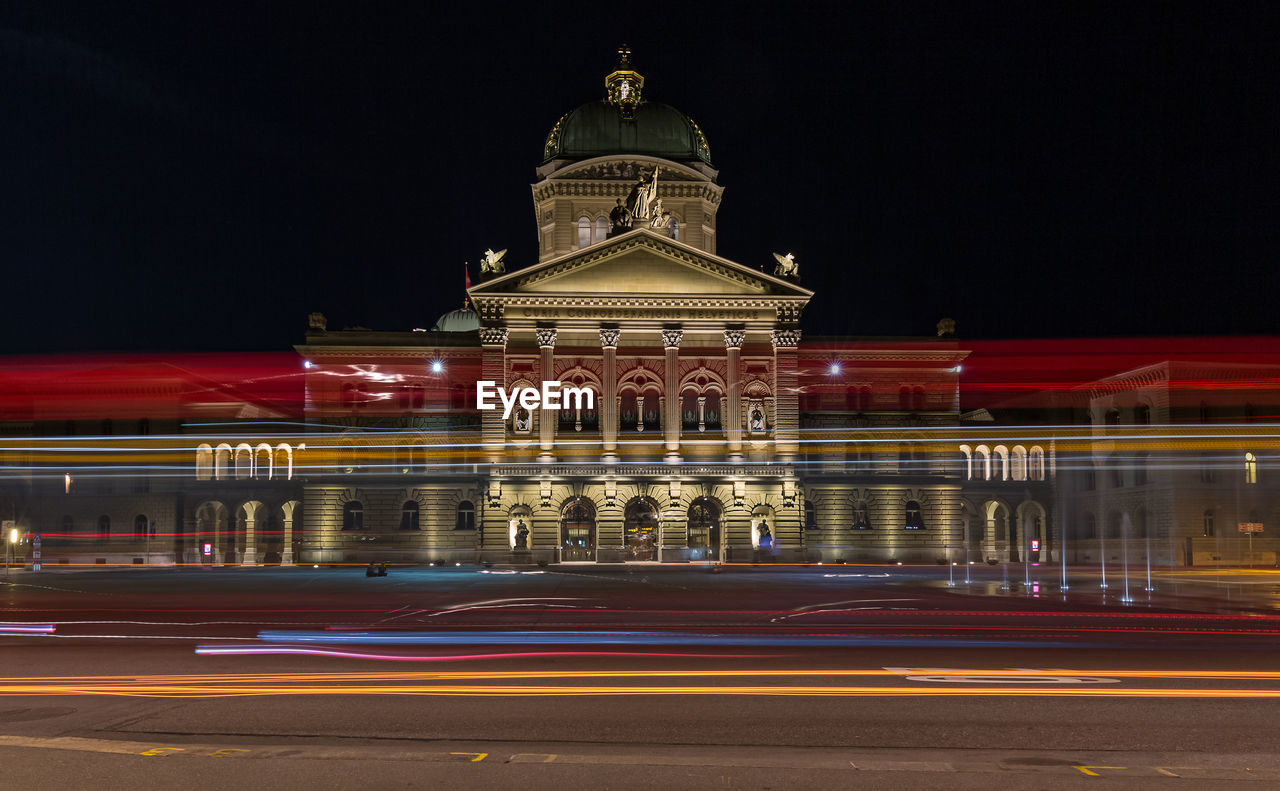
<box><xmin>0</xmin><ymin>566</ymin><xmax>1280</xmax><ymax>788</ymax></box>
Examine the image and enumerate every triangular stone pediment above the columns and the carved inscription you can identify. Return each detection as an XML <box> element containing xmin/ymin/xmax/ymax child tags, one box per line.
<box><xmin>471</xmin><ymin>229</ymin><xmax>813</xmax><ymax>300</ymax></box>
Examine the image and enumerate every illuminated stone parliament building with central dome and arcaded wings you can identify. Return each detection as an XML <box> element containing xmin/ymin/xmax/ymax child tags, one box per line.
<box><xmin>15</xmin><ymin>50</ymin><xmax>1280</xmax><ymax>566</ymax></box>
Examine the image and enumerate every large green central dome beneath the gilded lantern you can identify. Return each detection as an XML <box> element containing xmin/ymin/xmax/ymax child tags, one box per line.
<box><xmin>543</xmin><ymin>101</ymin><xmax>712</xmax><ymax>165</ymax></box>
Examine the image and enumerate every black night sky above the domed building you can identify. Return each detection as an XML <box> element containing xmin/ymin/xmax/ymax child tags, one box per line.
<box><xmin>0</xmin><ymin>0</ymin><xmax>1280</xmax><ymax>353</ymax></box>
